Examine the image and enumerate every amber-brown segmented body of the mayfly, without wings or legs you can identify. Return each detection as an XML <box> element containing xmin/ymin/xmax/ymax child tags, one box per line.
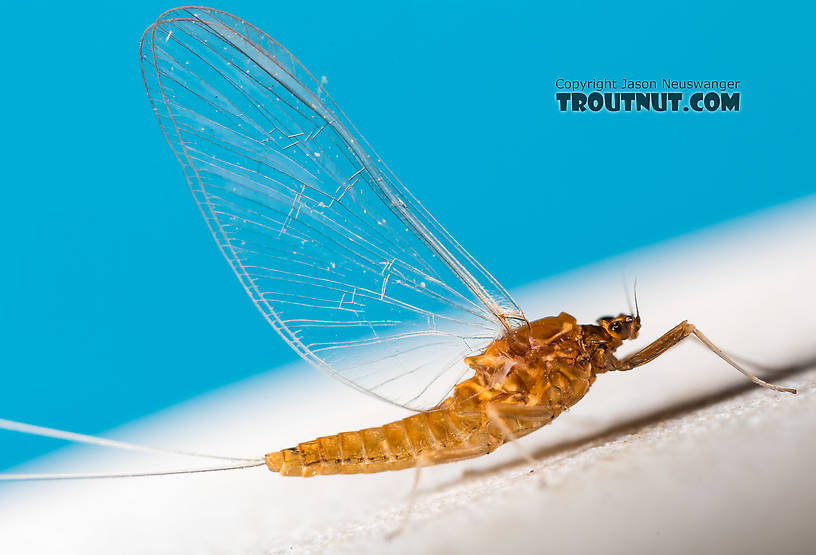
<box><xmin>265</xmin><ymin>312</ymin><xmax>628</xmax><ymax>476</ymax></box>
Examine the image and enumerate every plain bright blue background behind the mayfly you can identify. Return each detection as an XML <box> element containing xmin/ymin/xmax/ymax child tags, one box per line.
<box><xmin>0</xmin><ymin>1</ymin><xmax>816</xmax><ymax>467</ymax></box>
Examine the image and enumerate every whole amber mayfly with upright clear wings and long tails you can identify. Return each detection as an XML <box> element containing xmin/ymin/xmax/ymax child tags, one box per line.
<box><xmin>0</xmin><ymin>7</ymin><xmax>795</xmax><ymax>478</ymax></box>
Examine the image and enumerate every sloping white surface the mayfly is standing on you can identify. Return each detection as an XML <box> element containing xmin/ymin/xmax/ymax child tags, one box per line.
<box><xmin>0</xmin><ymin>199</ymin><xmax>816</xmax><ymax>554</ymax></box>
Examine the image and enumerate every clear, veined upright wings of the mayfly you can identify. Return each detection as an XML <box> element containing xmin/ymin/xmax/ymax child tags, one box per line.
<box><xmin>141</xmin><ymin>7</ymin><xmax>524</xmax><ymax>410</ymax></box>
